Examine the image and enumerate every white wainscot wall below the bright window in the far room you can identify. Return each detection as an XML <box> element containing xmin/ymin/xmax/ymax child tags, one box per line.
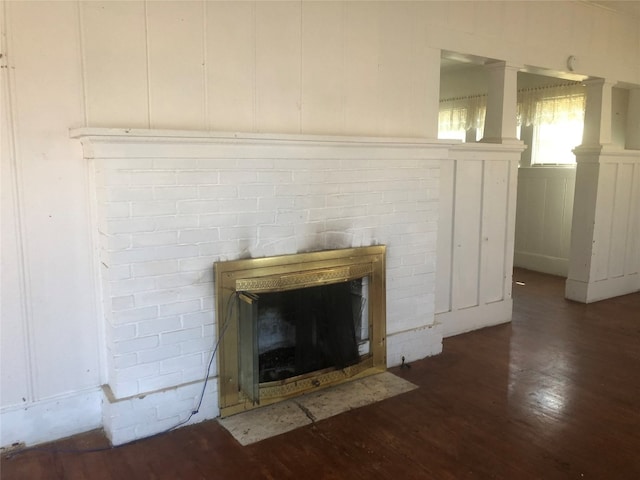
<box><xmin>514</xmin><ymin>167</ymin><xmax>576</xmax><ymax>277</ymax></box>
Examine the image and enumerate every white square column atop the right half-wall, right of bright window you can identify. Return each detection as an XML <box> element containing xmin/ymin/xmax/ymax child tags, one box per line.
<box><xmin>582</xmin><ymin>78</ymin><xmax>615</xmax><ymax>147</ymax></box>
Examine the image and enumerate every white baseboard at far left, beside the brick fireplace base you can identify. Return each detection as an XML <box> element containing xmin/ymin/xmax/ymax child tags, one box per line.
<box><xmin>0</xmin><ymin>387</ymin><xmax>102</xmax><ymax>447</ymax></box>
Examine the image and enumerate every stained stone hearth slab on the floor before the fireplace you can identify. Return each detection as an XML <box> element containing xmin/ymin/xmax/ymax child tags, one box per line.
<box><xmin>218</xmin><ymin>372</ymin><xmax>418</xmax><ymax>445</ymax></box>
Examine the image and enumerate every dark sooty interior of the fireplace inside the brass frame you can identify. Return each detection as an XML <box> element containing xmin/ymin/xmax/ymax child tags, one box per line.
<box><xmin>253</xmin><ymin>278</ymin><xmax>368</xmax><ymax>383</ymax></box>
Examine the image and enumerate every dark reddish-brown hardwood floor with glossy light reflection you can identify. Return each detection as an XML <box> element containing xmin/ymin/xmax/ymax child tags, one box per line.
<box><xmin>1</xmin><ymin>270</ymin><xmax>640</xmax><ymax>480</ymax></box>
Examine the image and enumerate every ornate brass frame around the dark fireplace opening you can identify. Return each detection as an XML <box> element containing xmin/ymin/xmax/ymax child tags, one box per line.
<box><xmin>214</xmin><ymin>245</ymin><xmax>387</xmax><ymax>417</ymax></box>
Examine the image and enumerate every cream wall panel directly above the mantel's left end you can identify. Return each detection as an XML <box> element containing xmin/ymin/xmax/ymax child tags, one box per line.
<box><xmin>80</xmin><ymin>1</ymin><xmax>149</xmax><ymax>128</ymax></box>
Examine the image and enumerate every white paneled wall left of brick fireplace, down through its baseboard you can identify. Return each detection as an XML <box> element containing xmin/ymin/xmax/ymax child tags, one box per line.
<box><xmin>0</xmin><ymin>2</ymin><xmax>101</xmax><ymax>445</ymax></box>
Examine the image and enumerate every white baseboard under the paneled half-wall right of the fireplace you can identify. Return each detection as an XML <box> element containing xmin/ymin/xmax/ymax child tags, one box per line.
<box><xmin>436</xmin><ymin>298</ymin><xmax>513</xmax><ymax>338</ymax></box>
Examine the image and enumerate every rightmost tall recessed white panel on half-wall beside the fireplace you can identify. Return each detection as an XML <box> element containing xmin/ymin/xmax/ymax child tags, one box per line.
<box><xmin>480</xmin><ymin>160</ymin><xmax>509</xmax><ymax>303</ymax></box>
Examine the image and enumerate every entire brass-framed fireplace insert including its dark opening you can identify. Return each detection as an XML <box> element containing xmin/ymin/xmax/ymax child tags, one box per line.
<box><xmin>215</xmin><ymin>246</ymin><xmax>386</xmax><ymax>416</ymax></box>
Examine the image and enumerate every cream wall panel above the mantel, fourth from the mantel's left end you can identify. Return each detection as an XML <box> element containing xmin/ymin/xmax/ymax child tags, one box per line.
<box><xmin>256</xmin><ymin>2</ymin><xmax>301</xmax><ymax>133</ymax></box>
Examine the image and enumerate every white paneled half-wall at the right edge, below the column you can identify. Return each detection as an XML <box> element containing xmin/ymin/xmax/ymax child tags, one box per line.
<box><xmin>566</xmin><ymin>147</ymin><xmax>640</xmax><ymax>303</ymax></box>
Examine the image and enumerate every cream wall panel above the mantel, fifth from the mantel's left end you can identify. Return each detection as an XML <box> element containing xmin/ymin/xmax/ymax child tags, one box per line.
<box><xmin>302</xmin><ymin>2</ymin><xmax>346</xmax><ymax>135</ymax></box>
